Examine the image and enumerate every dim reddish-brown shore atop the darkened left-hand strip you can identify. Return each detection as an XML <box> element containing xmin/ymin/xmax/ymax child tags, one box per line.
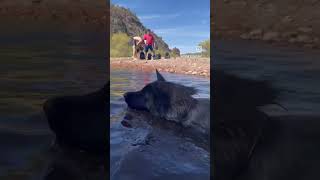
<box><xmin>0</xmin><ymin>0</ymin><xmax>109</xmax><ymax>32</ymax></box>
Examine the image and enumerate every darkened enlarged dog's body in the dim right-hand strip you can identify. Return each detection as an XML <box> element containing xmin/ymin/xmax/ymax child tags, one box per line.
<box><xmin>211</xmin><ymin>70</ymin><xmax>320</xmax><ymax>180</ymax></box>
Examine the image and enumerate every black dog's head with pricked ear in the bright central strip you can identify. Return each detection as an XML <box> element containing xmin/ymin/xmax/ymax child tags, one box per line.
<box><xmin>124</xmin><ymin>71</ymin><xmax>197</xmax><ymax>121</ymax></box>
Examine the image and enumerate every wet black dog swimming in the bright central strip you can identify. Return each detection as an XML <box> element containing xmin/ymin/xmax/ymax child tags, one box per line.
<box><xmin>122</xmin><ymin>71</ymin><xmax>210</xmax><ymax>136</ymax></box>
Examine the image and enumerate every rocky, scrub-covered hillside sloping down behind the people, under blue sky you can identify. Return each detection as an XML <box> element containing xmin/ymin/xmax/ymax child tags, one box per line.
<box><xmin>110</xmin><ymin>5</ymin><xmax>170</xmax><ymax>51</ymax></box>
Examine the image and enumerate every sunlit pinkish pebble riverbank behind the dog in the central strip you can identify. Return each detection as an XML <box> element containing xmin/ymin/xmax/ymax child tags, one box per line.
<box><xmin>110</xmin><ymin>57</ymin><xmax>210</xmax><ymax>78</ymax></box>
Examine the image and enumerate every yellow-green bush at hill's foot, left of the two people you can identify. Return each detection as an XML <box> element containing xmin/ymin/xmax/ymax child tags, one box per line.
<box><xmin>110</xmin><ymin>33</ymin><xmax>132</xmax><ymax>57</ymax></box>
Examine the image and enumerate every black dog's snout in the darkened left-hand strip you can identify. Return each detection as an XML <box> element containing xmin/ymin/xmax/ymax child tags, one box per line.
<box><xmin>43</xmin><ymin>83</ymin><xmax>110</xmax><ymax>152</ymax></box>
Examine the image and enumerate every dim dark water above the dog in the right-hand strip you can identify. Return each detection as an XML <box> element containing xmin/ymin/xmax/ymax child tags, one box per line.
<box><xmin>213</xmin><ymin>41</ymin><xmax>320</xmax><ymax>114</ymax></box>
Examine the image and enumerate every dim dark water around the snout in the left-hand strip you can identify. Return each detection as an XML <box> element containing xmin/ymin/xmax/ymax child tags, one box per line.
<box><xmin>0</xmin><ymin>33</ymin><xmax>107</xmax><ymax>180</ymax></box>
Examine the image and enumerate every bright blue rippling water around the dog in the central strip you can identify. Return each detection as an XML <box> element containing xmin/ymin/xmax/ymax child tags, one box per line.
<box><xmin>110</xmin><ymin>71</ymin><xmax>210</xmax><ymax>180</ymax></box>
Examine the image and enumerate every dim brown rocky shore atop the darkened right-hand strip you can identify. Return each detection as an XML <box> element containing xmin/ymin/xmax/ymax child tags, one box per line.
<box><xmin>211</xmin><ymin>0</ymin><xmax>320</xmax><ymax>48</ymax></box>
